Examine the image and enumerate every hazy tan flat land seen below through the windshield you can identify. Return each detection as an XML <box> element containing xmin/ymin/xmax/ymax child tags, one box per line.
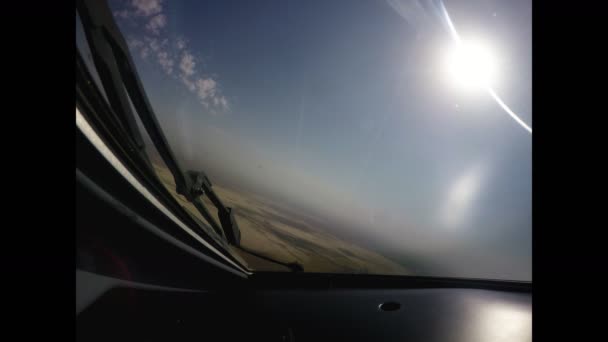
<box><xmin>153</xmin><ymin>158</ymin><xmax>410</xmax><ymax>275</ymax></box>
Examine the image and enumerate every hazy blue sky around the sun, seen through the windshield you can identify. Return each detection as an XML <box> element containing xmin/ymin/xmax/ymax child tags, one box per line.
<box><xmin>78</xmin><ymin>0</ymin><xmax>532</xmax><ymax>280</ymax></box>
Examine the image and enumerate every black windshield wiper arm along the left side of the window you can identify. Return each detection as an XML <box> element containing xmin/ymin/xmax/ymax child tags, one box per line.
<box><xmin>77</xmin><ymin>0</ymin><xmax>303</xmax><ymax>272</ymax></box>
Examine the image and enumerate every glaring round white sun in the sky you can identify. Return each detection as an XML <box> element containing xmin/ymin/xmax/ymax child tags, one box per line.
<box><xmin>444</xmin><ymin>41</ymin><xmax>496</xmax><ymax>90</ymax></box>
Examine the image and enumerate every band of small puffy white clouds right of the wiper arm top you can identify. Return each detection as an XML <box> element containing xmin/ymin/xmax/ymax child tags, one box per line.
<box><xmin>114</xmin><ymin>0</ymin><xmax>230</xmax><ymax>114</ymax></box>
